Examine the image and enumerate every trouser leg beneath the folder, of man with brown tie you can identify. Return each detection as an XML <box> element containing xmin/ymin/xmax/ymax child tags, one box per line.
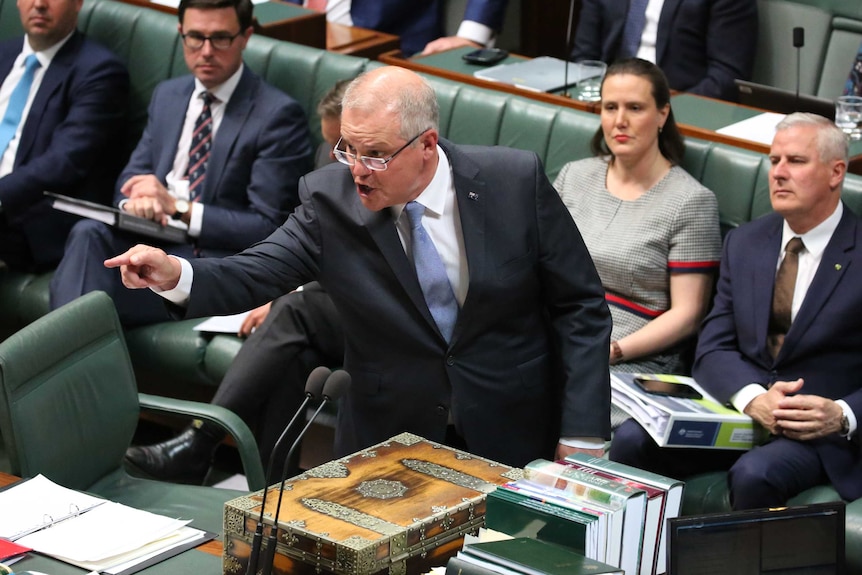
<box><xmin>610</xmin><ymin>419</ymin><xmax>742</xmax><ymax>479</ymax></box>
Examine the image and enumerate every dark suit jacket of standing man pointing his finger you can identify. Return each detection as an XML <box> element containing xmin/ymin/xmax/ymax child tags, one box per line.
<box><xmin>187</xmin><ymin>142</ymin><xmax>611</xmax><ymax>465</ymax></box>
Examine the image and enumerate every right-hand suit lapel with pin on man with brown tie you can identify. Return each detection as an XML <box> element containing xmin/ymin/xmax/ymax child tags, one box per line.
<box><xmin>778</xmin><ymin>206</ymin><xmax>856</xmax><ymax>359</ymax></box>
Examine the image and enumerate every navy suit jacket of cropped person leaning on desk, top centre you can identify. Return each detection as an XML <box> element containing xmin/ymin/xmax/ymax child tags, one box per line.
<box><xmin>289</xmin><ymin>0</ymin><xmax>507</xmax><ymax>56</ymax></box>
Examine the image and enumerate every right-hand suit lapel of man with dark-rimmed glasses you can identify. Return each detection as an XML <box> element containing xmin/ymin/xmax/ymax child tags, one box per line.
<box><xmin>201</xmin><ymin>67</ymin><xmax>258</xmax><ymax>203</ymax></box>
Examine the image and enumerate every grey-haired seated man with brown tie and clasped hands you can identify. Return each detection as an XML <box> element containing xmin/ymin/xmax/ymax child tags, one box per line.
<box><xmin>611</xmin><ymin>113</ymin><xmax>862</xmax><ymax>509</ymax></box>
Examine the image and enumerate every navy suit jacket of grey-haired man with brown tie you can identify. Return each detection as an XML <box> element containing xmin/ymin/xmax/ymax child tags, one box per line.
<box><xmin>693</xmin><ymin>206</ymin><xmax>862</xmax><ymax>499</ymax></box>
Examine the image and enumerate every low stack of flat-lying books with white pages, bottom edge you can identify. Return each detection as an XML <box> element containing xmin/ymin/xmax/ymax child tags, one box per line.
<box><xmin>446</xmin><ymin>537</ymin><xmax>623</xmax><ymax>575</ymax></box>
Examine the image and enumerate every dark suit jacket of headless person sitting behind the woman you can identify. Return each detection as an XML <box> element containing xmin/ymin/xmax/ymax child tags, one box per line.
<box><xmin>572</xmin><ymin>0</ymin><xmax>757</xmax><ymax>100</ymax></box>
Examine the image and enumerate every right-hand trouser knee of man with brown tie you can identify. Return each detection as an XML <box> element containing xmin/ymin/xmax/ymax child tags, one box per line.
<box><xmin>728</xmin><ymin>437</ymin><xmax>829</xmax><ymax>509</ymax></box>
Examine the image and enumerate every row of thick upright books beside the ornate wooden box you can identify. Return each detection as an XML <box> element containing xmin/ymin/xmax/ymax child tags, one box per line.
<box><xmin>486</xmin><ymin>454</ymin><xmax>683</xmax><ymax>575</ymax></box>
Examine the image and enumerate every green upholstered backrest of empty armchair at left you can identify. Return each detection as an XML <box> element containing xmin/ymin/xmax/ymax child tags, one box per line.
<box><xmin>0</xmin><ymin>292</ymin><xmax>138</xmax><ymax>489</ymax></box>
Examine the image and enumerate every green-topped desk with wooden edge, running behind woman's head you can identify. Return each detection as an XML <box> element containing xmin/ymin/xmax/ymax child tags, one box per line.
<box><xmin>378</xmin><ymin>48</ymin><xmax>862</xmax><ymax>174</ymax></box>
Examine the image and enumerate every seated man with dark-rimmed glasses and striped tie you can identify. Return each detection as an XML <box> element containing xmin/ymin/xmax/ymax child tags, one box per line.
<box><xmin>51</xmin><ymin>0</ymin><xmax>312</xmax><ymax>326</ymax></box>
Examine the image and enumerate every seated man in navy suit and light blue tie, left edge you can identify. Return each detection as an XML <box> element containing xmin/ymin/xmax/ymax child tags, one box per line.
<box><xmin>0</xmin><ymin>0</ymin><xmax>129</xmax><ymax>271</ymax></box>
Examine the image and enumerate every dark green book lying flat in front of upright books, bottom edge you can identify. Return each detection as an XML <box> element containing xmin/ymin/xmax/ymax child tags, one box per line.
<box><xmin>463</xmin><ymin>537</ymin><xmax>623</xmax><ymax>575</ymax></box>
